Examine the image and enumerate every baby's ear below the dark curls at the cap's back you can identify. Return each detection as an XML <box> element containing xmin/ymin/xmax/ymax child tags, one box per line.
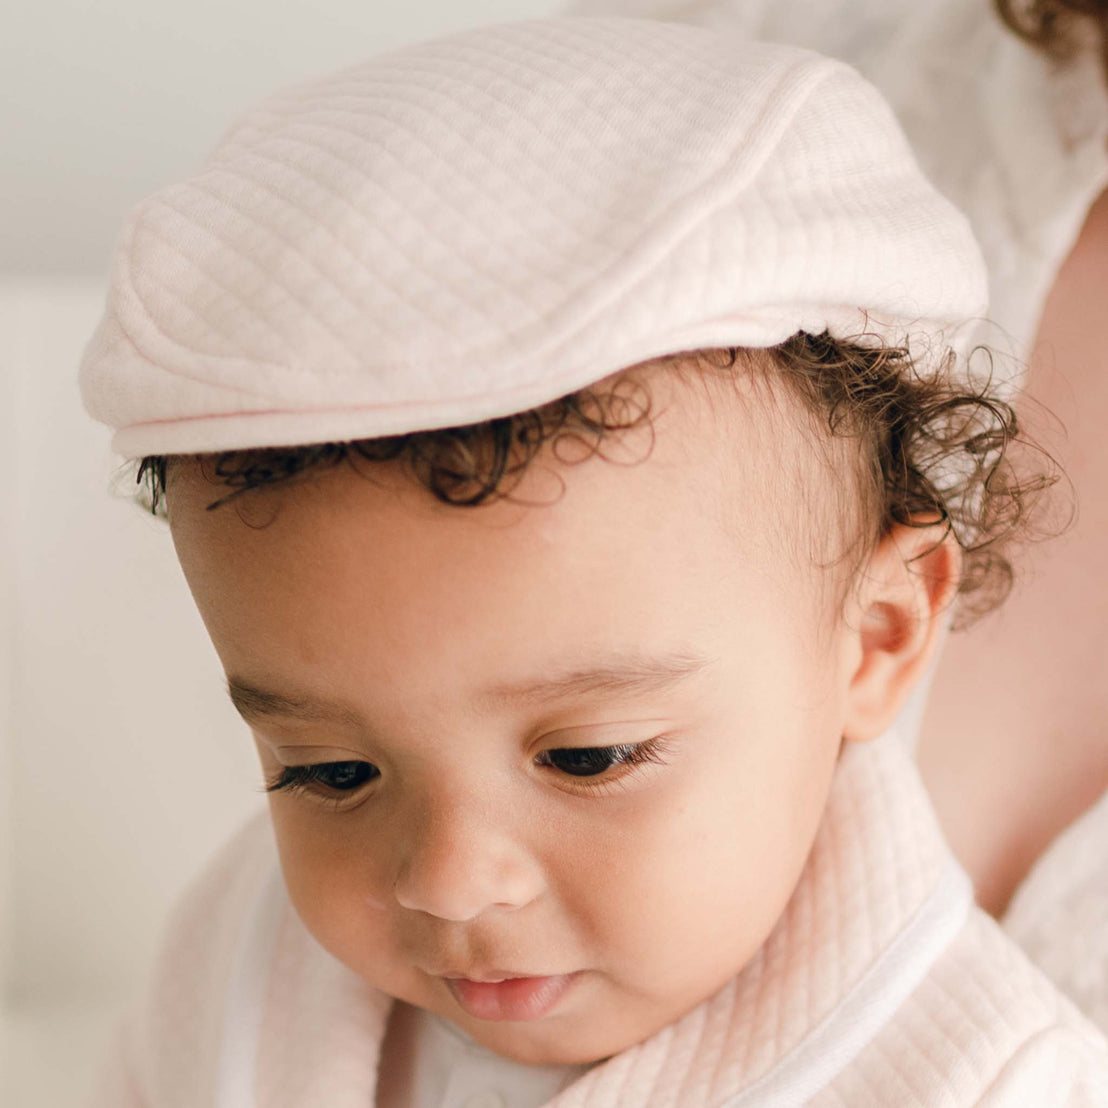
<box><xmin>843</xmin><ymin>523</ymin><xmax>962</xmax><ymax>742</ymax></box>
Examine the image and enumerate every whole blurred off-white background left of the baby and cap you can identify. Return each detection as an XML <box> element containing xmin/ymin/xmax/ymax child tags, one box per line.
<box><xmin>0</xmin><ymin>0</ymin><xmax>563</xmax><ymax>1108</ymax></box>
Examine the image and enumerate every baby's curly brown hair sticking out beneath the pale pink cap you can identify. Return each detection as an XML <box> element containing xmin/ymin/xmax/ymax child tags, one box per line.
<box><xmin>136</xmin><ymin>331</ymin><xmax>1060</xmax><ymax>628</ymax></box>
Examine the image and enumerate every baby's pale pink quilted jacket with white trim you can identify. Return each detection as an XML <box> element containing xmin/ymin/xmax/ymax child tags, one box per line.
<box><xmin>81</xmin><ymin>741</ymin><xmax>1108</xmax><ymax>1108</ymax></box>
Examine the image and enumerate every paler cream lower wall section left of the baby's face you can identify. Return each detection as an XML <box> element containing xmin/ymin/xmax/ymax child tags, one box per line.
<box><xmin>0</xmin><ymin>278</ymin><xmax>263</xmax><ymax>1108</ymax></box>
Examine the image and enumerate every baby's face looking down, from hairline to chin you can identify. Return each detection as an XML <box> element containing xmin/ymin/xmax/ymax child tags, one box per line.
<box><xmin>170</xmin><ymin>363</ymin><xmax>856</xmax><ymax>1064</ymax></box>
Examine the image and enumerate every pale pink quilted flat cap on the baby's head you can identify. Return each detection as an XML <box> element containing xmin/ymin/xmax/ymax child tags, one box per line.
<box><xmin>80</xmin><ymin>17</ymin><xmax>986</xmax><ymax>456</ymax></box>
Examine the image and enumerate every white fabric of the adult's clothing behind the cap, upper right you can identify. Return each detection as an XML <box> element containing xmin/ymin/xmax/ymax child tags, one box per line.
<box><xmin>564</xmin><ymin>0</ymin><xmax>1108</xmax><ymax>399</ymax></box>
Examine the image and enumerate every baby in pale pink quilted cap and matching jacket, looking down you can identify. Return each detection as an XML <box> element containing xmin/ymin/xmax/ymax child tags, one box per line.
<box><xmin>82</xmin><ymin>10</ymin><xmax>1108</xmax><ymax>1108</ymax></box>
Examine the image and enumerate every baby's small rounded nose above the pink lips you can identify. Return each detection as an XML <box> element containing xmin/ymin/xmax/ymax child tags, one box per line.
<box><xmin>393</xmin><ymin>800</ymin><xmax>545</xmax><ymax>922</ymax></box>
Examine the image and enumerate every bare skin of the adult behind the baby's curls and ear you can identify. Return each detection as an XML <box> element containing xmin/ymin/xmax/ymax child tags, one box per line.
<box><xmin>919</xmin><ymin>192</ymin><xmax>1108</xmax><ymax>916</ymax></box>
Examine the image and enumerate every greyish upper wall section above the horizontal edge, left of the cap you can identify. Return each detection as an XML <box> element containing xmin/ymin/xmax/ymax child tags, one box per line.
<box><xmin>0</xmin><ymin>0</ymin><xmax>562</xmax><ymax>273</ymax></box>
